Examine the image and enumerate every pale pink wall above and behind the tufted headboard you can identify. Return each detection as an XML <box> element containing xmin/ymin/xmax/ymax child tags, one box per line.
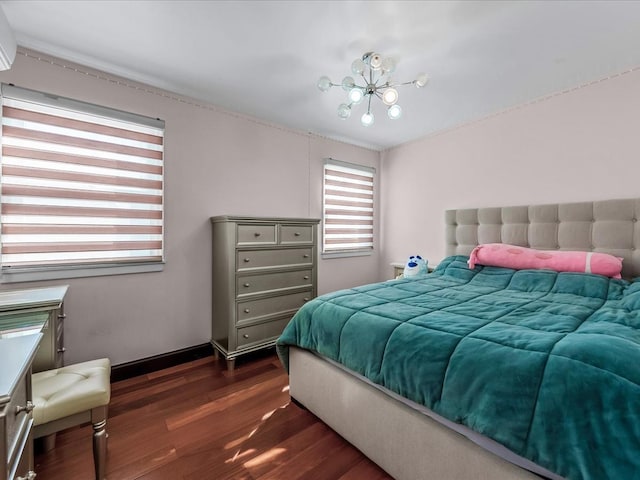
<box><xmin>380</xmin><ymin>70</ymin><xmax>640</xmax><ymax>275</ymax></box>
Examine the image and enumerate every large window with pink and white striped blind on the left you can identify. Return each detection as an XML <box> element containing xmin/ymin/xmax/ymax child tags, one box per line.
<box><xmin>0</xmin><ymin>84</ymin><xmax>164</xmax><ymax>282</ymax></box>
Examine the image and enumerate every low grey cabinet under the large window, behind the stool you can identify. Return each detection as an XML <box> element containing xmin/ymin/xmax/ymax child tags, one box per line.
<box><xmin>0</xmin><ymin>285</ymin><xmax>68</xmax><ymax>372</ymax></box>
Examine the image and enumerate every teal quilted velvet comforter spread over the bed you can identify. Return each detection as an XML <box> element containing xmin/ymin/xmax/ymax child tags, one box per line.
<box><xmin>277</xmin><ymin>256</ymin><xmax>640</xmax><ymax>480</ymax></box>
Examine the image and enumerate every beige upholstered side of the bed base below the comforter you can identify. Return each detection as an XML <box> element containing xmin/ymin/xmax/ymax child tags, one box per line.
<box><xmin>289</xmin><ymin>347</ymin><xmax>545</xmax><ymax>480</ymax></box>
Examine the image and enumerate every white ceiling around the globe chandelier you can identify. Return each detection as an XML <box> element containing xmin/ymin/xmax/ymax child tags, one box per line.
<box><xmin>0</xmin><ymin>0</ymin><xmax>640</xmax><ymax>149</ymax></box>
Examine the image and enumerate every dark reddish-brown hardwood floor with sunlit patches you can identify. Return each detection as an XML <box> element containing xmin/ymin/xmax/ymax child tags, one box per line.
<box><xmin>35</xmin><ymin>350</ymin><xmax>391</xmax><ymax>480</ymax></box>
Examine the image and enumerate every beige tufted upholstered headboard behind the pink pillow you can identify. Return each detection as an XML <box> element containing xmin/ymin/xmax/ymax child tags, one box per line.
<box><xmin>445</xmin><ymin>198</ymin><xmax>640</xmax><ymax>278</ymax></box>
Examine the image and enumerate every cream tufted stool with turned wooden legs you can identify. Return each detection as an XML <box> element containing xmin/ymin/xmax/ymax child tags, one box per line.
<box><xmin>31</xmin><ymin>358</ymin><xmax>111</xmax><ymax>480</ymax></box>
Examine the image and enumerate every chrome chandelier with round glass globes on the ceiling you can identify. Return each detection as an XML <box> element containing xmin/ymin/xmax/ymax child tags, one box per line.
<box><xmin>318</xmin><ymin>52</ymin><xmax>429</xmax><ymax>127</ymax></box>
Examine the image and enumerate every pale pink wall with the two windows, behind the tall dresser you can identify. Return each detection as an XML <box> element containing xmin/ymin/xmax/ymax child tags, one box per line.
<box><xmin>0</xmin><ymin>49</ymin><xmax>379</xmax><ymax>365</ymax></box>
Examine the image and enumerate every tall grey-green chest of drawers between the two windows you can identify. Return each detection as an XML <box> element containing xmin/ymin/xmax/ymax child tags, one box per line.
<box><xmin>211</xmin><ymin>215</ymin><xmax>320</xmax><ymax>372</ymax></box>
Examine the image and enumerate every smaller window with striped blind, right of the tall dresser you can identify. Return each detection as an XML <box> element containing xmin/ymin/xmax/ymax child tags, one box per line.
<box><xmin>322</xmin><ymin>159</ymin><xmax>376</xmax><ymax>255</ymax></box>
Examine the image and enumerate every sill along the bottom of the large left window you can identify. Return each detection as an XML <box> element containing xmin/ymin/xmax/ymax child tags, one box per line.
<box><xmin>0</xmin><ymin>262</ymin><xmax>164</xmax><ymax>284</ymax></box>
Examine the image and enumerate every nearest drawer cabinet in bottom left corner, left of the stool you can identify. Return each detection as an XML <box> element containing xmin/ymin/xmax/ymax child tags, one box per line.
<box><xmin>0</xmin><ymin>333</ymin><xmax>42</xmax><ymax>480</ymax></box>
